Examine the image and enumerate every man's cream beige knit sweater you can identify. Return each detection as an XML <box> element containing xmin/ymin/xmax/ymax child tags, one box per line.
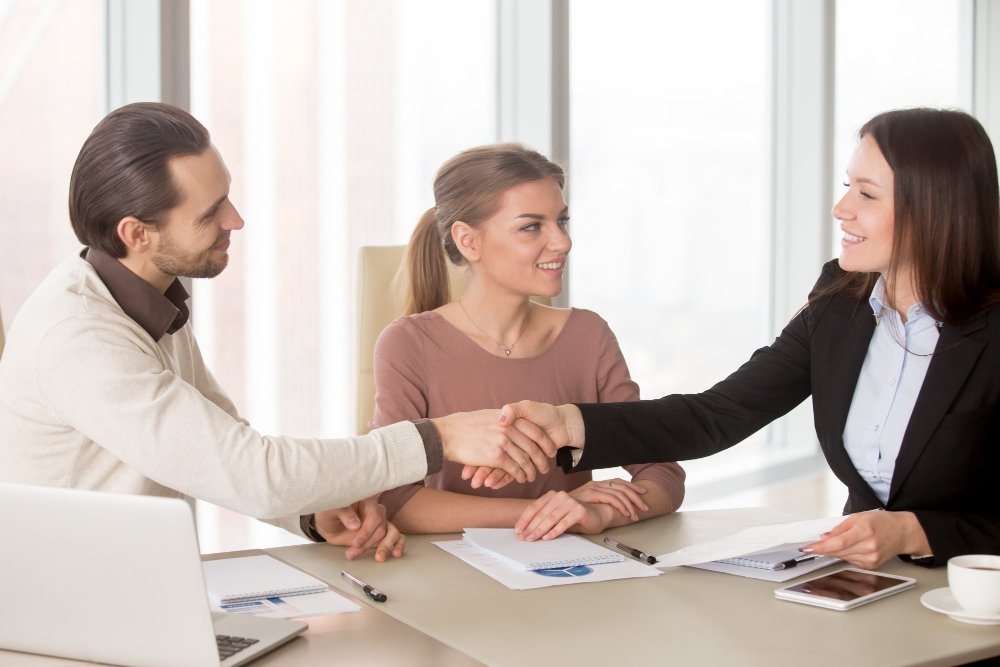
<box><xmin>0</xmin><ymin>257</ymin><xmax>427</xmax><ymax>533</ymax></box>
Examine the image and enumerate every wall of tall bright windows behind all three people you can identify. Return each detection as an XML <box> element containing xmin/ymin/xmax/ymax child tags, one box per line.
<box><xmin>0</xmin><ymin>0</ymin><xmax>984</xmax><ymax>550</ymax></box>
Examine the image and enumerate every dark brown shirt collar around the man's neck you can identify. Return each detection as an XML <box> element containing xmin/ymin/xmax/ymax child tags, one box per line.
<box><xmin>80</xmin><ymin>248</ymin><xmax>191</xmax><ymax>342</ymax></box>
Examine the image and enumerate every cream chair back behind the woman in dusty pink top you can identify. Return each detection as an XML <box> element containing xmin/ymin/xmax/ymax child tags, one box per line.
<box><xmin>356</xmin><ymin>245</ymin><xmax>552</xmax><ymax>433</ymax></box>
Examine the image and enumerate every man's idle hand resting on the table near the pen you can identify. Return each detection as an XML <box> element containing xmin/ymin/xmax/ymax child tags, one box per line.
<box><xmin>316</xmin><ymin>496</ymin><xmax>406</xmax><ymax>563</ymax></box>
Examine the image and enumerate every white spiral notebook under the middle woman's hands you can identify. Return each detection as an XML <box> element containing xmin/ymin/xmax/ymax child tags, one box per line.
<box><xmin>462</xmin><ymin>528</ymin><xmax>625</xmax><ymax>570</ymax></box>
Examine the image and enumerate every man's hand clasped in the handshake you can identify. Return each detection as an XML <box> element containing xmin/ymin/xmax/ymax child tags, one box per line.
<box><xmin>431</xmin><ymin>410</ymin><xmax>556</xmax><ymax>488</ymax></box>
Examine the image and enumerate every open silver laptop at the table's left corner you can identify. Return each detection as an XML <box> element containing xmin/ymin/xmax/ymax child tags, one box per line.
<box><xmin>0</xmin><ymin>484</ymin><xmax>308</xmax><ymax>667</ymax></box>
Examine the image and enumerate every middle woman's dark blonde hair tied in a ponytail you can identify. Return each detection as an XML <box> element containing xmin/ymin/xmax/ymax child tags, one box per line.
<box><xmin>406</xmin><ymin>144</ymin><xmax>566</xmax><ymax>314</ymax></box>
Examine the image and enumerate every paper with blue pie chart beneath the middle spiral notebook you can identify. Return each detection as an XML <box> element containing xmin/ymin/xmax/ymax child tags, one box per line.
<box><xmin>433</xmin><ymin>540</ymin><xmax>661</xmax><ymax>590</ymax></box>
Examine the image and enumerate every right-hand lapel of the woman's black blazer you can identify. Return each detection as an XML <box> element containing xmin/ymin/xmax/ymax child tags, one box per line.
<box><xmin>887</xmin><ymin>317</ymin><xmax>986</xmax><ymax>504</ymax></box>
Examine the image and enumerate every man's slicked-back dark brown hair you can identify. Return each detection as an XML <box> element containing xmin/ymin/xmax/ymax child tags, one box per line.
<box><xmin>69</xmin><ymin>102</ymin><xmax>210</xmax><ymax>257</ymax></box>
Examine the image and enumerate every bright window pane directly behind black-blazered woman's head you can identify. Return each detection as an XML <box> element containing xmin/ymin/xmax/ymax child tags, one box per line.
<box><xmin>833</xmin><ymin>0</ymin><xmax>971</xmax><ymax>247</ymax></box>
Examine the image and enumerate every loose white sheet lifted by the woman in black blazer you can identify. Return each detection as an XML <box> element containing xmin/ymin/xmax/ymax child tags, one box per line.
<box><xmin>656</xmin><ymin>516</ymin><xmax>844</xmax><ymax>568</ymax></box>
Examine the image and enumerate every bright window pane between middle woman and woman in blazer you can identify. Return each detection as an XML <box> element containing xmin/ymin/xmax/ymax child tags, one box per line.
<box><xmin>570</xmin><ymin>0</ymin><xmax>771</xmax><ymax>481</ymax></box>
